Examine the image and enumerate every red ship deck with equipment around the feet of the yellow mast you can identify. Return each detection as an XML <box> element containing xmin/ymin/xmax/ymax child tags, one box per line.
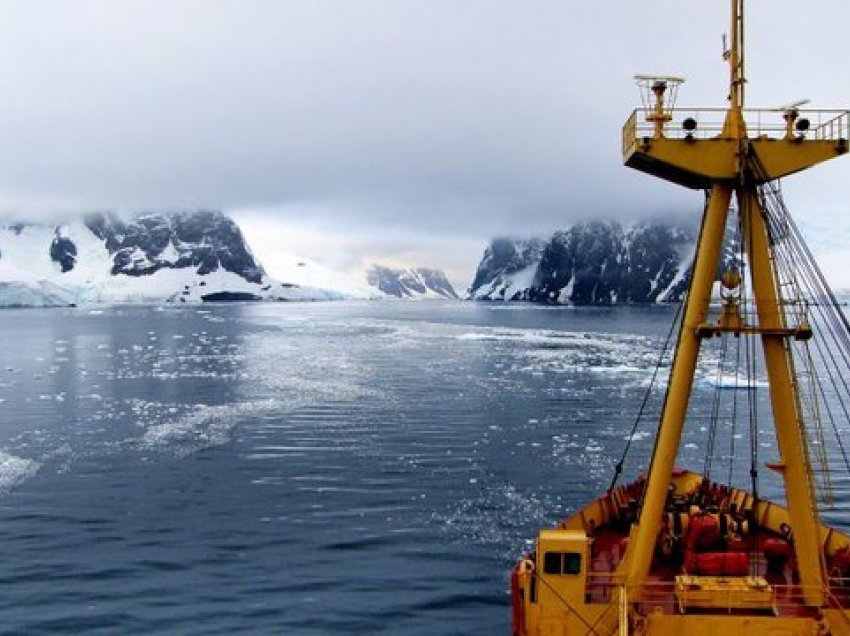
<box><xmin>573</xmin><ymin>474</ymin><xmax>850</xmax><ymax>617</ymax></box>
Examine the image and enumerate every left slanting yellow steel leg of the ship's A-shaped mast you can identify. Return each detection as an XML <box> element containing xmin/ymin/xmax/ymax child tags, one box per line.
<box><xmin>626</xmin><ymin>184</ymin><xmax>732</xmax><ymax>585</ymax></box>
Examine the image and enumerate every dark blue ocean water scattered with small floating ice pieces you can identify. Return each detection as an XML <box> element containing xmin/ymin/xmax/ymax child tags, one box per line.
<box><xmin>0</xmin><ymin>302</ymin><xmax>846</xmax><ymax>634</ymax></box>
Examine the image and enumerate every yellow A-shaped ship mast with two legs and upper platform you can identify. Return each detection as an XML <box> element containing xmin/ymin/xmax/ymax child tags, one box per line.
<box><xmin>623</xmin><ymin>0</ymin><xmax>847</xmax><ymax>606</ymax></box>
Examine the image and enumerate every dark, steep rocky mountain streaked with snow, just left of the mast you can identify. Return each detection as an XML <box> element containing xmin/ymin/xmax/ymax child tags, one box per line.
<box><xmin>468</xmin><ymin>221</ymin><xmax>695</xmax><ymax>304</ymax></box>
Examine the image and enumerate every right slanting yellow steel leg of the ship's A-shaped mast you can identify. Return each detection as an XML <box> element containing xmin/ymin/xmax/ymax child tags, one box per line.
<box><xmin>736</xmin><ymin>187</ymin><xmax>825</xmax><ymax>607</ymax></box>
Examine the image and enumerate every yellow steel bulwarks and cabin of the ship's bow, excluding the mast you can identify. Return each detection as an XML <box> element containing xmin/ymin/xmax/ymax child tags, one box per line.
<box><xmin>517</xmin><ymin>471</ymin><xmax>850</xmax><ymax>636</ymax></box>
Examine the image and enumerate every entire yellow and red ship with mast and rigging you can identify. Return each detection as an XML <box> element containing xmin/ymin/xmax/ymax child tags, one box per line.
<box><xmin>510</xmin><ymin>0</ymin><xmax>850</xmax><ymax>636</ymax></box>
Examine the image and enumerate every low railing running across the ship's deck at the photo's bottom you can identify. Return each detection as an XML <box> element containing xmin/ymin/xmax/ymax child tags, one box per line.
<box><xmin>585</xmin><ymin>573</ymin><xmax>850</xmax><ymax>616</ymax></box>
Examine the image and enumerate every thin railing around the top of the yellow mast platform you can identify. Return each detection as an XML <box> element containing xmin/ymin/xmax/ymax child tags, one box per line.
<box><xmin>623</xmin><ymin>108</ymin><xmax>850</xmax><ymax>146</ymax></box>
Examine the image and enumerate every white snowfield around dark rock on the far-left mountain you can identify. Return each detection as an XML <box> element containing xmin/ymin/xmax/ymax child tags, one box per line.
<box><xmin>0</xmin><ymin>221</ymin><xmax>376</xmax><ymax>307</ymax></box>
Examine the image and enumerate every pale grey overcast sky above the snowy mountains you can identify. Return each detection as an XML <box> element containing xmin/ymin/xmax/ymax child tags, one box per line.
<box><xmin>0</xmin><ymin>0</ymin><xmax>850</xmax><ymax>286</ymax></box>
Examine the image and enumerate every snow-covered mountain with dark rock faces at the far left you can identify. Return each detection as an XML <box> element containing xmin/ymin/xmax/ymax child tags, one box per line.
<box><xmin>0</xmin><ymin>211</ymin><xmax>356</xmax><ymax>306</ymax></box>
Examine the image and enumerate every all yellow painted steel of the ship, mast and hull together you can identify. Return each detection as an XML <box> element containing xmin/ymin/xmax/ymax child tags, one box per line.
<box><xmin>516</xmin><ymin>0</ymin><xmax>850</xmax><ymax>636</ymax></box>
